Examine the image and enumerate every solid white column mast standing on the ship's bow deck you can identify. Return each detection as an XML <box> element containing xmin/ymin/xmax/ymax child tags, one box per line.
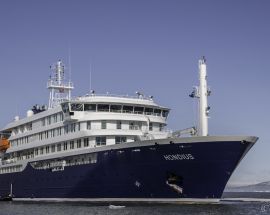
<box><xmin>189</xmin><ymin>56</ymin><xmax>211</xmax><ymax>136</ymax></box>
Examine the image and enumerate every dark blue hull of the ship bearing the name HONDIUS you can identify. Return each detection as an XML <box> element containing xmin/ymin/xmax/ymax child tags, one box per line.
<box><xmin>0</xmin><ymin>141</ymin><xmax>254</xmax><ymax>201</ymax></box>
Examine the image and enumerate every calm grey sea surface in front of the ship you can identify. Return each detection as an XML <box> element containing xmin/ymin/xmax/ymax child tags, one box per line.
<box><xmin>0</xmin><ymin>193</ymin><xmax>270</xmax><ymax>215</ymax></box>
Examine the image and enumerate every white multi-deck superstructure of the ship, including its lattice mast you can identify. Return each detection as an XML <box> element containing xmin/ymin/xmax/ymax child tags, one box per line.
<box><xmin>0</xmin><ymin>61</ymin><xmax>171</xmax><ymax>174</ymax></box>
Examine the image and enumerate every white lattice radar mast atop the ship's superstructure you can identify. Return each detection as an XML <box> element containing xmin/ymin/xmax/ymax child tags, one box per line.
<box><xmin>47</xmin><ymin>60</ymin><xmax>74</xmax><ymax>108</ymax></box>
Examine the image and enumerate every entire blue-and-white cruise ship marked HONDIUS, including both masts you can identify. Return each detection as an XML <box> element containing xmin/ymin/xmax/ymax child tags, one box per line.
<box><xmin>0</xmin><ymin>58</ymin><xmax>258</xmax><ymax>202</ymax></box>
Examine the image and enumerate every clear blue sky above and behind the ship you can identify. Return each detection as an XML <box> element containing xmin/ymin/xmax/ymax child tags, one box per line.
<box><xmin>0</xmin><ymin>0</ymin><xmax>270</xmax><ymax>184</ymax></box>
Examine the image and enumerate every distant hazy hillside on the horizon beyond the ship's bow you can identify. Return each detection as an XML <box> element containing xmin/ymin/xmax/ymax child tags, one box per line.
<box><xmin>225</xmin><ymin>181</ymin><xmax>270</xmax><ymax>192</ymax></box>
